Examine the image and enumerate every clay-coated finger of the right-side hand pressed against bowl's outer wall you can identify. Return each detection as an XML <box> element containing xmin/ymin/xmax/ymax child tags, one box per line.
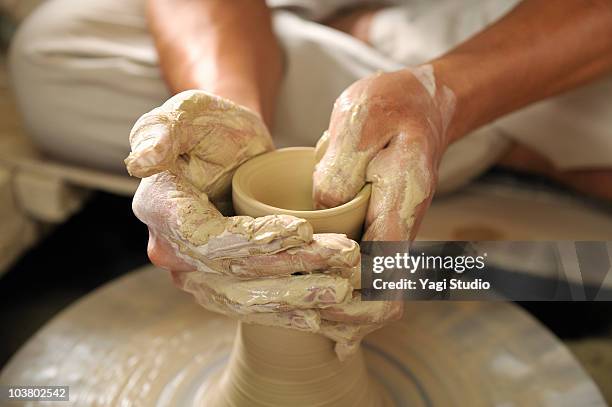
<box><xmin>363</xmin><ymin>133</ymin><xmax>435</xmax><ymax>241</ymax></box>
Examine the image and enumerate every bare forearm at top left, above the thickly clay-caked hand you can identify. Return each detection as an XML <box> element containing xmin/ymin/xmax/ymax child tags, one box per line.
<box><xmin>147</xmin><ymin>0</ymin><xmax>283</xmax><ymax>124</ymax></box>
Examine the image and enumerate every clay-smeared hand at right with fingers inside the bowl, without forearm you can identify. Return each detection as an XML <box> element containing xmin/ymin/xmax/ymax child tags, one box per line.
<box><xmin>314</xmin><ymin>65</ymin><xmax>455</xmax><ymax>240</ymax></box>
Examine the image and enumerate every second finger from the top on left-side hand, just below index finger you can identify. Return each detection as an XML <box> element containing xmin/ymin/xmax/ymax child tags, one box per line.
<box><xmin>224</xmin><ymin>233</ymin><xmax>361</xmax><ymax>281</ymax></box>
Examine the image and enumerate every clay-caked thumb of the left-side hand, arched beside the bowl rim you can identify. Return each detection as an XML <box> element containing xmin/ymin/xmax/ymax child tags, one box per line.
<box><xmin>125</xmin><ymin>90</ymin><xmax>272</xmax><ymax>184</ymax></box>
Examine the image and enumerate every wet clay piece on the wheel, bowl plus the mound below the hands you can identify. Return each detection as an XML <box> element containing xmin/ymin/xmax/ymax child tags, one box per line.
<box><xmin>210</xmin><ymin>148</ymin><xmax>392</xmax><ymax>407</ymax></box>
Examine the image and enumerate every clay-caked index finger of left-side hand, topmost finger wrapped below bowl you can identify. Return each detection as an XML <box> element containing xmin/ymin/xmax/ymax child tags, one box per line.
<box><xmin>132</xmin><ymin>172</ymin><xmax>312</xmax><ymax>272</ymax></box>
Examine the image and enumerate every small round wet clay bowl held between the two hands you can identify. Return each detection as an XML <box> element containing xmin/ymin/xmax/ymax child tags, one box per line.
<box><xmin>232</xmin><ymin>147</ymin><xmax>371</xmax><ymax>240</ymax></box>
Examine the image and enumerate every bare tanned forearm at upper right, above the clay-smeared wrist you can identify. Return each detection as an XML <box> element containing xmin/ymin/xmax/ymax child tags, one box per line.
<box><xmin>432</xmin><ymin>0</ymin><xmax>612</xmax><ymax>141</ymax></box>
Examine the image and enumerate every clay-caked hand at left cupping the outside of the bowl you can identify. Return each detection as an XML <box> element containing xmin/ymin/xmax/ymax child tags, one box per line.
<box><xmin>126</xmin><ymin>91</ymin><xmax>399</xmax><ymax>357</ymax></box>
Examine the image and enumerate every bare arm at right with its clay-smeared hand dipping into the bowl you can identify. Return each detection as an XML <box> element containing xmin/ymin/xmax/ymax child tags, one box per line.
<box><xmin>314</xmin><ymin>0</ymin><xmax>612</xmax><ymax>240</ymax></box>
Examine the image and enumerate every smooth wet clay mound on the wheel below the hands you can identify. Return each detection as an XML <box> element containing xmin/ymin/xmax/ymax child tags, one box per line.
<box><xmin>203</xmin><ymin>324</ymin><xmax>392</xmax><ymax>407</ymax></box>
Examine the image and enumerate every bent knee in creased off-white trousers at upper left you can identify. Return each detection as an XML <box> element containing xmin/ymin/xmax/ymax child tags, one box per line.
<box><xmin>9</xmin><ymin>0</ymin><xmax>168</xmax><ymax>172</ymax></box>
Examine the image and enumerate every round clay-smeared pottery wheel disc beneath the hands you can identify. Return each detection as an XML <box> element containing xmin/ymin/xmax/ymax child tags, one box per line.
<box><xmin>0</xmin><ymin>267</ymin><xmax>606</xmax><ymax>407</ymax></box>
